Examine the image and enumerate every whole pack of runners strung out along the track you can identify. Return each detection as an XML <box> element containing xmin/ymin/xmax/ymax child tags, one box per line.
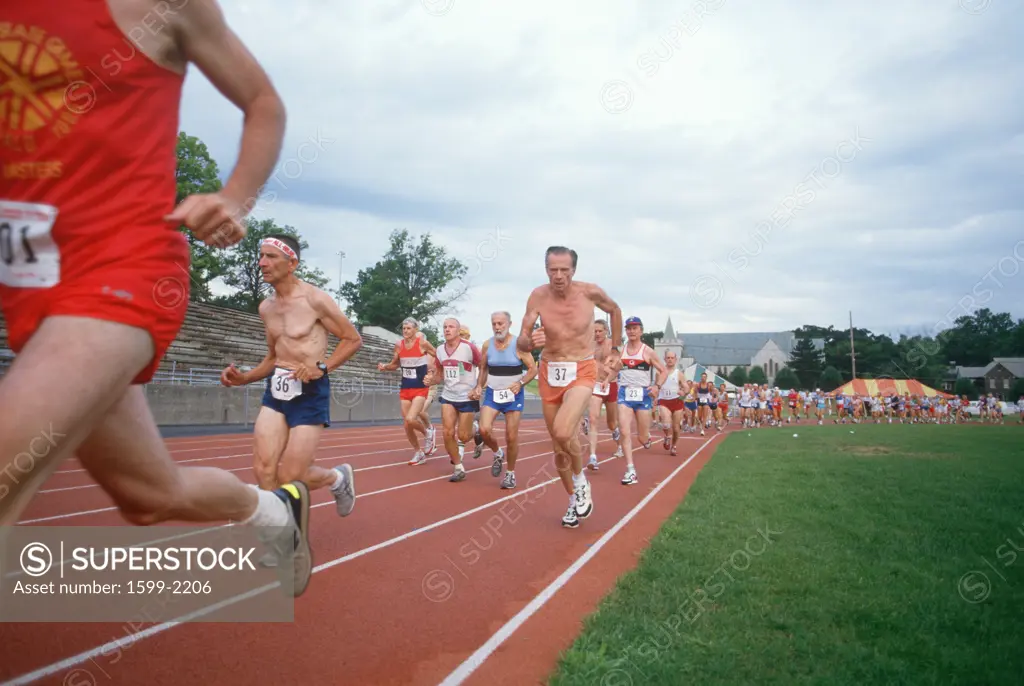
<box><xmin>0</xmin><ymin>0</ymin><xmax>1019</xmax><ymax>596</ymax></box>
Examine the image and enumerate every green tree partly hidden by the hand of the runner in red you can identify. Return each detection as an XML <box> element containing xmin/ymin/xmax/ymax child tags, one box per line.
<box><xmin>175</xmin><ymin>131</ymin><xmax>225</xmax><ymax>302</ymax></box>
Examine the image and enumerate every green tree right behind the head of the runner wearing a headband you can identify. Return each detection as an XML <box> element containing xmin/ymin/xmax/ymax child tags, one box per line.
<box><xmin>213</xmin><ymin>218</ymin><xmax>329</xmax><ymax>313</ymax></box>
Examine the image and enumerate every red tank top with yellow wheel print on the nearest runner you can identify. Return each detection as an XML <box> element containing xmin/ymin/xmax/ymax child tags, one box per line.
<box><xmin>0</xmin><ymin>0</ymin><xmax>187</xmax><ymax>292</ymax></box>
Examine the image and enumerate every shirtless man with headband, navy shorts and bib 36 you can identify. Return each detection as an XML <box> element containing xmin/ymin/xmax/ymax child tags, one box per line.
<box><xmin>220</xmin><ymin>234</ymin><xmax>362</xmax><ymax>528</ymax></box>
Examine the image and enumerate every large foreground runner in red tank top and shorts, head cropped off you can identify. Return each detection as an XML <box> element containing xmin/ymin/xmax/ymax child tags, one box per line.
<box><xmin>0</xmin><ymin>0</ymin><xmax>310</xmax><ymax>595</ymax></box>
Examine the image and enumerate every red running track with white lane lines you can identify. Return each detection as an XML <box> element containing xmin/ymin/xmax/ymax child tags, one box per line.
<box><xmin>0</xmin><ymin>420</ymin><xmax>722</xmax><ymax>686</ymax></box>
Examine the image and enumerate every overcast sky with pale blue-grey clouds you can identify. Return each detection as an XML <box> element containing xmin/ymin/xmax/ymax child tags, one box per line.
<box><xmin>181</xmin><ymin>0</ymin><xmax>1024</xmax><ymax>341</ymax></box>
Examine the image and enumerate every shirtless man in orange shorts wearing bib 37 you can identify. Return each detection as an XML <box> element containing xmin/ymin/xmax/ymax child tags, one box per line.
<box><xmin>518</xmin><ymin>246</ymin><xmax>623</xmax><ymax>528</ymax></box>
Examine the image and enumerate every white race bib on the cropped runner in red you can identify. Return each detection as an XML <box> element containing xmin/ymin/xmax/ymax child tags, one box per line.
<box><xmin>0</xmin><ymin>200</ymin><xmax>60</xmax><ymax>288</ymax></box>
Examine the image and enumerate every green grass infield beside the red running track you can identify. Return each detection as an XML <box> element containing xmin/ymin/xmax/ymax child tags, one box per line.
<box><xmin>550</xmin><ymin>425</ymin><xmax>1024</xmax><ymax>686</ymax></box>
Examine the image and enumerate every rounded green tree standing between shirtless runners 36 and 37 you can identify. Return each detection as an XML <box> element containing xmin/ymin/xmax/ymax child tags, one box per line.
<box><xmin>340</xmin><ymin>229</ymin><xmax>468</xmax><ymax>331</ymax></box>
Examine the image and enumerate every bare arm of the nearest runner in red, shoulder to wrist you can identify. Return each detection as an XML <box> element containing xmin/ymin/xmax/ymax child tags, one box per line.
<box><xmin>173</xmin><ymin>0</ymin><xmax>286</xmax><ymax>216</ymax></box>
